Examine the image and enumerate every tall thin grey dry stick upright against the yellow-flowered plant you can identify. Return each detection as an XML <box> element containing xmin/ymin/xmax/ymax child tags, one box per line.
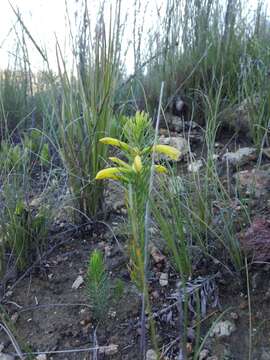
<box><xmin>141</xmin><ymin>81</ymin><xmax>164</xmax><ymax>359</ymax></box>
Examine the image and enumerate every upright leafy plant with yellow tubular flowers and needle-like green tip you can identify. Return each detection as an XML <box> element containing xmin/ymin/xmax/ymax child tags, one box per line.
<box><xmin>96</xmin><ymin>112</ymin><xmax>180</xmax><ymax>289</ymax></box>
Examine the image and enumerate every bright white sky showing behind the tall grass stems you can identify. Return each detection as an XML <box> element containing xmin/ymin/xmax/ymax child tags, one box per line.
<box><xmin>0</xmin><ymin>0</ymin><xmax>270</xmax><ymax>71</ymax></box>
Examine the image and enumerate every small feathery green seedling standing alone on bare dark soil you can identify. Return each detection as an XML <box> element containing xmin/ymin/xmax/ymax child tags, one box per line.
<box><xmin>87</xmin><ymin>250</ymin><xmax>109</xmax><ymax>320</ymax></box>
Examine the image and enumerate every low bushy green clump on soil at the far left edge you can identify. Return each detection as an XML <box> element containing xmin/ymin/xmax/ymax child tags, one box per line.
<box><xmin>0</xmin><ymin>176</ymin><xmax>52</xmax><ymax>271</ymax></box>
